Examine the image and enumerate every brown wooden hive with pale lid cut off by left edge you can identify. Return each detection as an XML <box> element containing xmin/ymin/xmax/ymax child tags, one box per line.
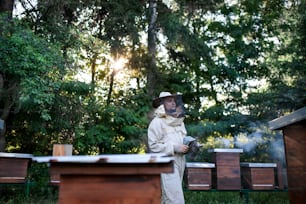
<box><xmin>0</xmin><ymin>152</ymin><xmax>32</xmax><ymax>183</ymax></box>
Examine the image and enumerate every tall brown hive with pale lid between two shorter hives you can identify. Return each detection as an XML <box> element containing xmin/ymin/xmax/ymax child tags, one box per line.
<box><xmin>208</xmin><ymin>148</ymin><xmax>243</xmax><ymax>190</ymax></box>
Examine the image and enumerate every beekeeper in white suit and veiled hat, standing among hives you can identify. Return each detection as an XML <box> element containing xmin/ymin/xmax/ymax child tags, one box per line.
<box><xmin>148</xmin><ymin>92</ymin><xmax>188</xmax><ymax>204</ymax></box>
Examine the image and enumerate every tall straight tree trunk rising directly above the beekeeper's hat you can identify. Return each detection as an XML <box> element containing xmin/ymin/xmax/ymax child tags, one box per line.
<box><xmin>147</xmin><ymin>0</ymin><xmax>159</xmax><ymax>98</ymax></box>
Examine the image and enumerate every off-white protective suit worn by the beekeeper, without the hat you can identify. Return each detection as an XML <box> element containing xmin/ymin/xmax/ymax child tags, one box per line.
<box><xmin>148</xmin><ymin>93</ymin><xmax>186</xmax><ymax>204</ymax></box>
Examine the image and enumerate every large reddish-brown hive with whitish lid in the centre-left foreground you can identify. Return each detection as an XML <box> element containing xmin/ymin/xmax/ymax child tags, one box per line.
<box><xmin>33</xmin><ymin>154</ymin><xmax>174</xmax><ymax>204</ymax></box>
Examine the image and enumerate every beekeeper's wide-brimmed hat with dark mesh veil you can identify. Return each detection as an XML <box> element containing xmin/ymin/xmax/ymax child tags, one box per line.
<box><xmin>152</xmin><ymin>92</ymin><xmax>185</xmax><ymax>118</ymax></box>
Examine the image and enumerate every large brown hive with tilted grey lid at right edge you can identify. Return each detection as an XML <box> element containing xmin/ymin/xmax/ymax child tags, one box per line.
<box><xmin>269</xmin><ymin>107</ymin><xmax>306</xmax><ymax>204</ymax></box>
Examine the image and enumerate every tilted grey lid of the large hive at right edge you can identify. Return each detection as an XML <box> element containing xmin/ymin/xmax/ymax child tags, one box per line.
<box><xmin>269</xmin><ymin>107</ymin><xmax>306</xmax><ymax>130</ymax></box>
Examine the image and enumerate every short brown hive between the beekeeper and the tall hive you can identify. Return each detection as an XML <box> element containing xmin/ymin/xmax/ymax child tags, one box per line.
<box><xmin>184</xmin><ymin>162</ymin><xmax>215</xmax><ymax>190</ymax></box>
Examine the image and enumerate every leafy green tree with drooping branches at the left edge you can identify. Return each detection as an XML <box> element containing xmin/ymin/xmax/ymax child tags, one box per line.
<box><xmin>0</xmin><ymin>18</ymin><xmax>62</xmax><ymax>151</ymax></box>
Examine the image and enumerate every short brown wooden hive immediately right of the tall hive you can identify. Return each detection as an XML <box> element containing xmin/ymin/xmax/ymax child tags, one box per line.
<box><xmin>241</xmin><ymin>162</ymin><xmax>277</xmax><ymax>190</ymax></box>
